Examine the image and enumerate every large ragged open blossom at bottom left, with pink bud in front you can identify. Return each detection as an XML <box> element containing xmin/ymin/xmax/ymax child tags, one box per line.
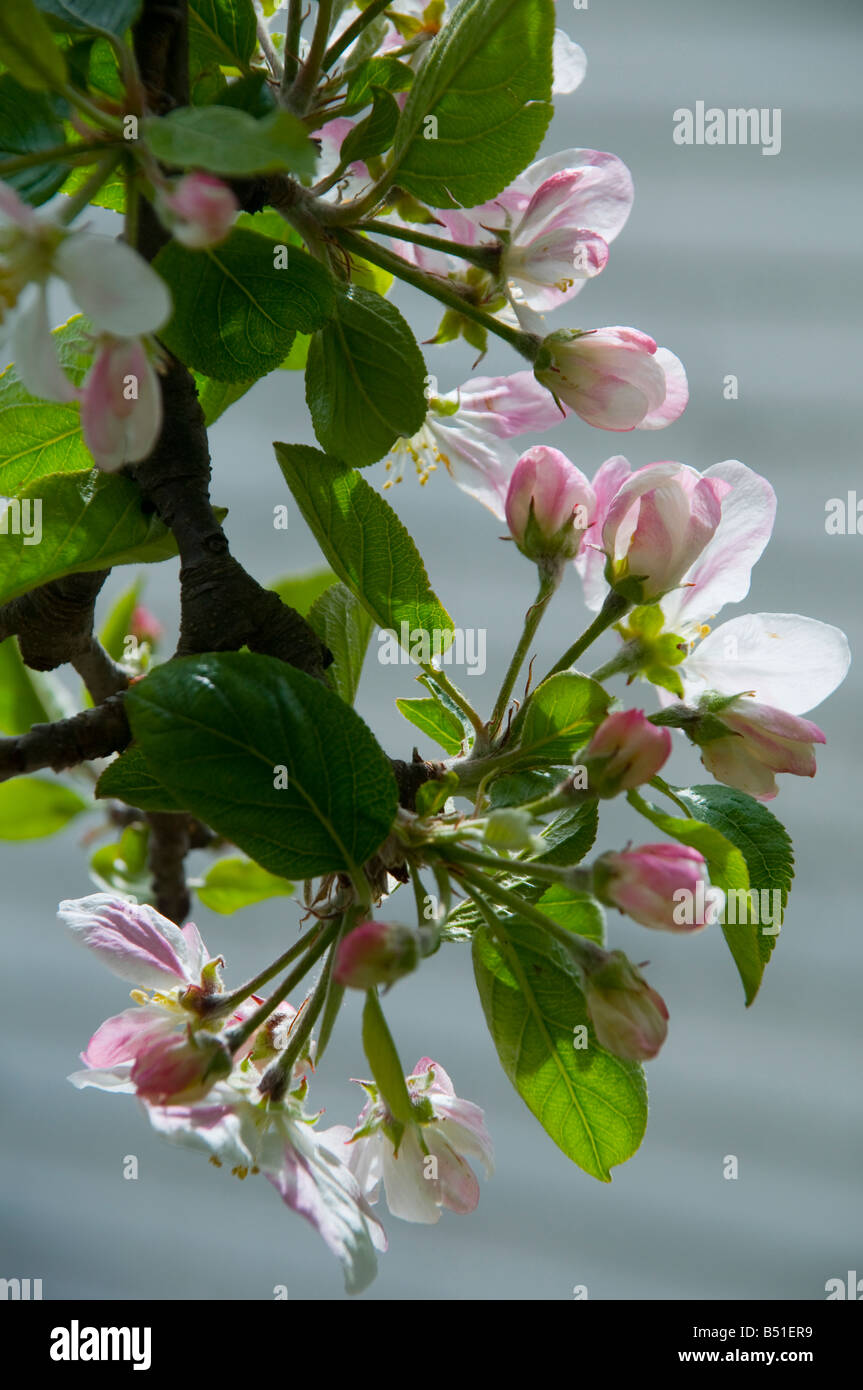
<box><xmin>58</xmin><ymin>894</ymin><xmax>386</xmax><ymax>1293</ymax></box>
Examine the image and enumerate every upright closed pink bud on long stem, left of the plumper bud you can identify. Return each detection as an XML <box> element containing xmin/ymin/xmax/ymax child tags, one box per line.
<box><xmin>506</xmin><ymin>445</ymin><xmax>596</xmax><ymax>560</ymax></box>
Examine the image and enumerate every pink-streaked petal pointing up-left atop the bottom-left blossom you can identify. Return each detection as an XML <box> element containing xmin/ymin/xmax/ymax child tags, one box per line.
<box><xmin>57</xmin><ymin>892</ymin><xmax>207</xmax><ymax>990</ymax></box>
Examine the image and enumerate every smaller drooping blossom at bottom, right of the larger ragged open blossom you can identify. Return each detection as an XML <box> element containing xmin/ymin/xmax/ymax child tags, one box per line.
<box><xmin>321</xmin><ymin>1056</ymin><xmax>493</xmax><ymax>1223</ymax></box>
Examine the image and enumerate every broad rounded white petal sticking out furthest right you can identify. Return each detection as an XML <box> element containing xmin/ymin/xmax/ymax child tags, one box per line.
<box><xmin>680</xmin><ymin>613</ymin><xmax>850</xmax><ymax>714</ymax></box>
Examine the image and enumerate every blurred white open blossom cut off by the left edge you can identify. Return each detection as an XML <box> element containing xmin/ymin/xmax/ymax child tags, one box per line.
<box><xmin>0</xmin><ymin>183</ymin><xmax>171</xmax><ymax>402</ymax></box>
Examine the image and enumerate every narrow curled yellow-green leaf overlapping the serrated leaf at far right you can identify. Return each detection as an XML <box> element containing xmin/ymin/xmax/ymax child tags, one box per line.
<box><xmin>627</xmin><ymin>791</ymin><xmax>764</xmax><ymax>1005</ymax></box>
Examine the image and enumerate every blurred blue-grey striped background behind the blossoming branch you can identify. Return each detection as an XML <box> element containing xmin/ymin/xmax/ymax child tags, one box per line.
<box><xmin>0</xmin><ymin>0</ymin><xmax>863</xmax><ymax>1300</ymax></box>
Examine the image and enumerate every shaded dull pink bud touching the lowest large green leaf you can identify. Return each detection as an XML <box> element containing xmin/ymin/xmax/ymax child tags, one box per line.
<box><xmin>585</xmin><ymin>951</ymin><xmax>668</xmax><ymax>1062</ymax></box>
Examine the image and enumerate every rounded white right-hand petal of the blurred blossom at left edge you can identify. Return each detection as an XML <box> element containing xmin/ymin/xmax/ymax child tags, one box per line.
<box><xmin>54</xmin><ymin>232</ymin><xmax>171</xmax><ymax>338</ymax></box>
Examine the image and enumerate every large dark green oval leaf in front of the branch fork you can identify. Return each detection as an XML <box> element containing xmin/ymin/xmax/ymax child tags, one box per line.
<box><xmin>126</xmin><ymin>652</ymin><xmax>397</xmax><ymax>878</ymax></box>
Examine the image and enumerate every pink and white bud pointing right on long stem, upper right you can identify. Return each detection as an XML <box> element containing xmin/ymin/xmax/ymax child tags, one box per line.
<box><xmin>535</xmin><ymin>328</ymin><xmax>689</xmax><ymax>430</ymax></box>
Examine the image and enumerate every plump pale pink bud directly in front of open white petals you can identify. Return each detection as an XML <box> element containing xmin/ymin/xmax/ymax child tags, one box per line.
<box><xmin>602</xmin><ymin>463</ymin><xmax>731</xmax><ymax>603</ymax></box>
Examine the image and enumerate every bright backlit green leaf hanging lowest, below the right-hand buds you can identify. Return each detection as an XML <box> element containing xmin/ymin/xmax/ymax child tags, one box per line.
<box><xmin>472</xmin><ymin>899</ymin><xmax>648</xmax><ymax>1183</ymax></box>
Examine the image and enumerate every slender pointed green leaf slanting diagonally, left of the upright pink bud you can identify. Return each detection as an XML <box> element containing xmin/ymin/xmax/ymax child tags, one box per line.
<box><xmin>275</xmin><ymin>443</ymin><xmax>453</xmax><ymax>648</ymax></box>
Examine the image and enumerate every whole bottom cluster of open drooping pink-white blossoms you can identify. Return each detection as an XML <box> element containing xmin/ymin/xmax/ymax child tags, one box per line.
<box><xmin>58</xmin><ymin>894</ymin><xmax>492</xmax><ymax>1293</ymax></box>
